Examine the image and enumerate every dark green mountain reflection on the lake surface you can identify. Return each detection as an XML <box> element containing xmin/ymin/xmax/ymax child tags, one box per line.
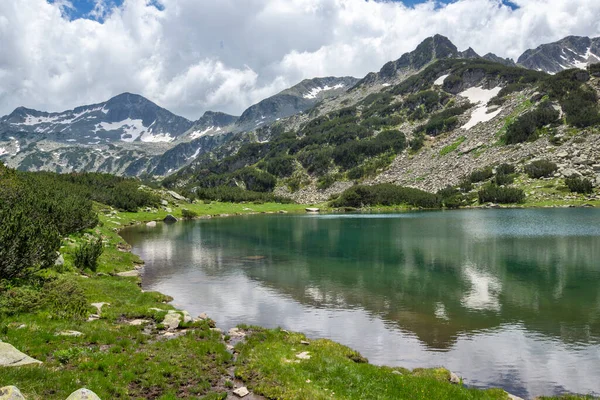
<box><xmin>119</xmin><ymin>210</ymin><xmax>600</xmax><ymax>349</ymax></box>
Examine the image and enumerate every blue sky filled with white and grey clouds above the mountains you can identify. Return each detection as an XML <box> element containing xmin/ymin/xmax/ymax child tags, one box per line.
<box><xmin>0</xmin><ymin>0</ymin><xmax>600</xmax><ymax>120</ymax></box>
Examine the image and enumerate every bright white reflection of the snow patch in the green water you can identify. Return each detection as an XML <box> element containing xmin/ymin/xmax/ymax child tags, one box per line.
<box><xmin>461</xmin><ymin>265</ymin><xmax>502</xmax><ymax>311</ymax></box>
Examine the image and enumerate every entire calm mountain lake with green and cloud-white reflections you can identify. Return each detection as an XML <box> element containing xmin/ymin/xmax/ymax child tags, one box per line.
<box><xmin>122</xmin><ymin>209</ymin><xmax>600</xmax><ymax>397</ymax></box>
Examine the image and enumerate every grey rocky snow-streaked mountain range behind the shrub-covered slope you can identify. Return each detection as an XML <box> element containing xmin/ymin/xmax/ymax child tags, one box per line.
<box><xmin>0</xmin><ymin>35</ymin><xmax>600</xmax><ymax>186</ymax></box>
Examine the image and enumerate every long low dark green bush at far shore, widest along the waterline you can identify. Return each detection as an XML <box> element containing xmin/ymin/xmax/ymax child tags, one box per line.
<box><xmin>332</xmin><ymin>183</ymin><xmax>441</xmax><ymax>208</ymax></box>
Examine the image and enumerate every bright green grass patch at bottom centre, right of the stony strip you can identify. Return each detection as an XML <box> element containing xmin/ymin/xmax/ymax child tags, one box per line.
<box><xmin>236</xmin><ymin>328</ymin><xmax>507</xmax><ymax>400</ymax></box>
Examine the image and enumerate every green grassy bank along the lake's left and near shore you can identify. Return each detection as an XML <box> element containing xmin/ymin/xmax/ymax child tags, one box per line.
<box><xmin>0</xmin><ymin>198</ymin><xmax>596</xmax><ymax>400</ymax></box>
